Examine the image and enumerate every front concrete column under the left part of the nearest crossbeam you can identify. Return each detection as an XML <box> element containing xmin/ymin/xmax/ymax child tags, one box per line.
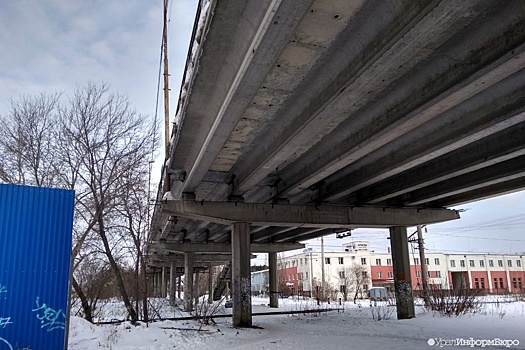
<box><xmin>231</xmin><ymin>222</ymin><xmax>252</xmax><ymax>327</ymax></box>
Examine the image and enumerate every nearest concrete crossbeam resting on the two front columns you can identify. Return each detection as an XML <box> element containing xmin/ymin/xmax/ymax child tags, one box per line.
<box><xmin>162</xmin><ymin>201</ymin><xmax>459</xmax><ymax>228</ymax></box>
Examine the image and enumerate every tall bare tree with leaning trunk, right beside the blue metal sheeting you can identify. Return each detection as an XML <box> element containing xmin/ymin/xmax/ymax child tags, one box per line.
<box><xmin>60</xmin><ymin>84</ymin><xmax>154</xmax><ymax>323</ymax></box>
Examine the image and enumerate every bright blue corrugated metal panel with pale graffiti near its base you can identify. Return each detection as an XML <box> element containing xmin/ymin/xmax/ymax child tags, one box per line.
<box><xmin>0</xmin><ymin>184</ymin><xmax>75</xmax><ymax>350</ymax></box>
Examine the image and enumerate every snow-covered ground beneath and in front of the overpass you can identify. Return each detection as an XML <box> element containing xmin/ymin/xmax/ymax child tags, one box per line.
<box><xmin>69</xmin><ymin>298</ymin><xmax>525</xmax><ymax>350</ymax></box>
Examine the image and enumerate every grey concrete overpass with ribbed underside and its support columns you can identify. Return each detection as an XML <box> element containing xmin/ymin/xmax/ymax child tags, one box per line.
<box><xmin>146</xmin><ymin>0</ymin><xmax>525</xmax><ymax>326</ymax></box>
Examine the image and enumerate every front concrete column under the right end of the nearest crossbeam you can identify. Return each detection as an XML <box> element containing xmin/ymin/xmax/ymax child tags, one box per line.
<box><xmin>390</xmin><ymin>226</ymin><xmax>414</xmax><ymax>320</ymax></box>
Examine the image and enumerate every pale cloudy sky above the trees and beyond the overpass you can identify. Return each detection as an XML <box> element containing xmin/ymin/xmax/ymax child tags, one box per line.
<box><xmin>0</xmin><ymin>0</ymin><xmax>525</xmax><ymax>262</ymax></box>
